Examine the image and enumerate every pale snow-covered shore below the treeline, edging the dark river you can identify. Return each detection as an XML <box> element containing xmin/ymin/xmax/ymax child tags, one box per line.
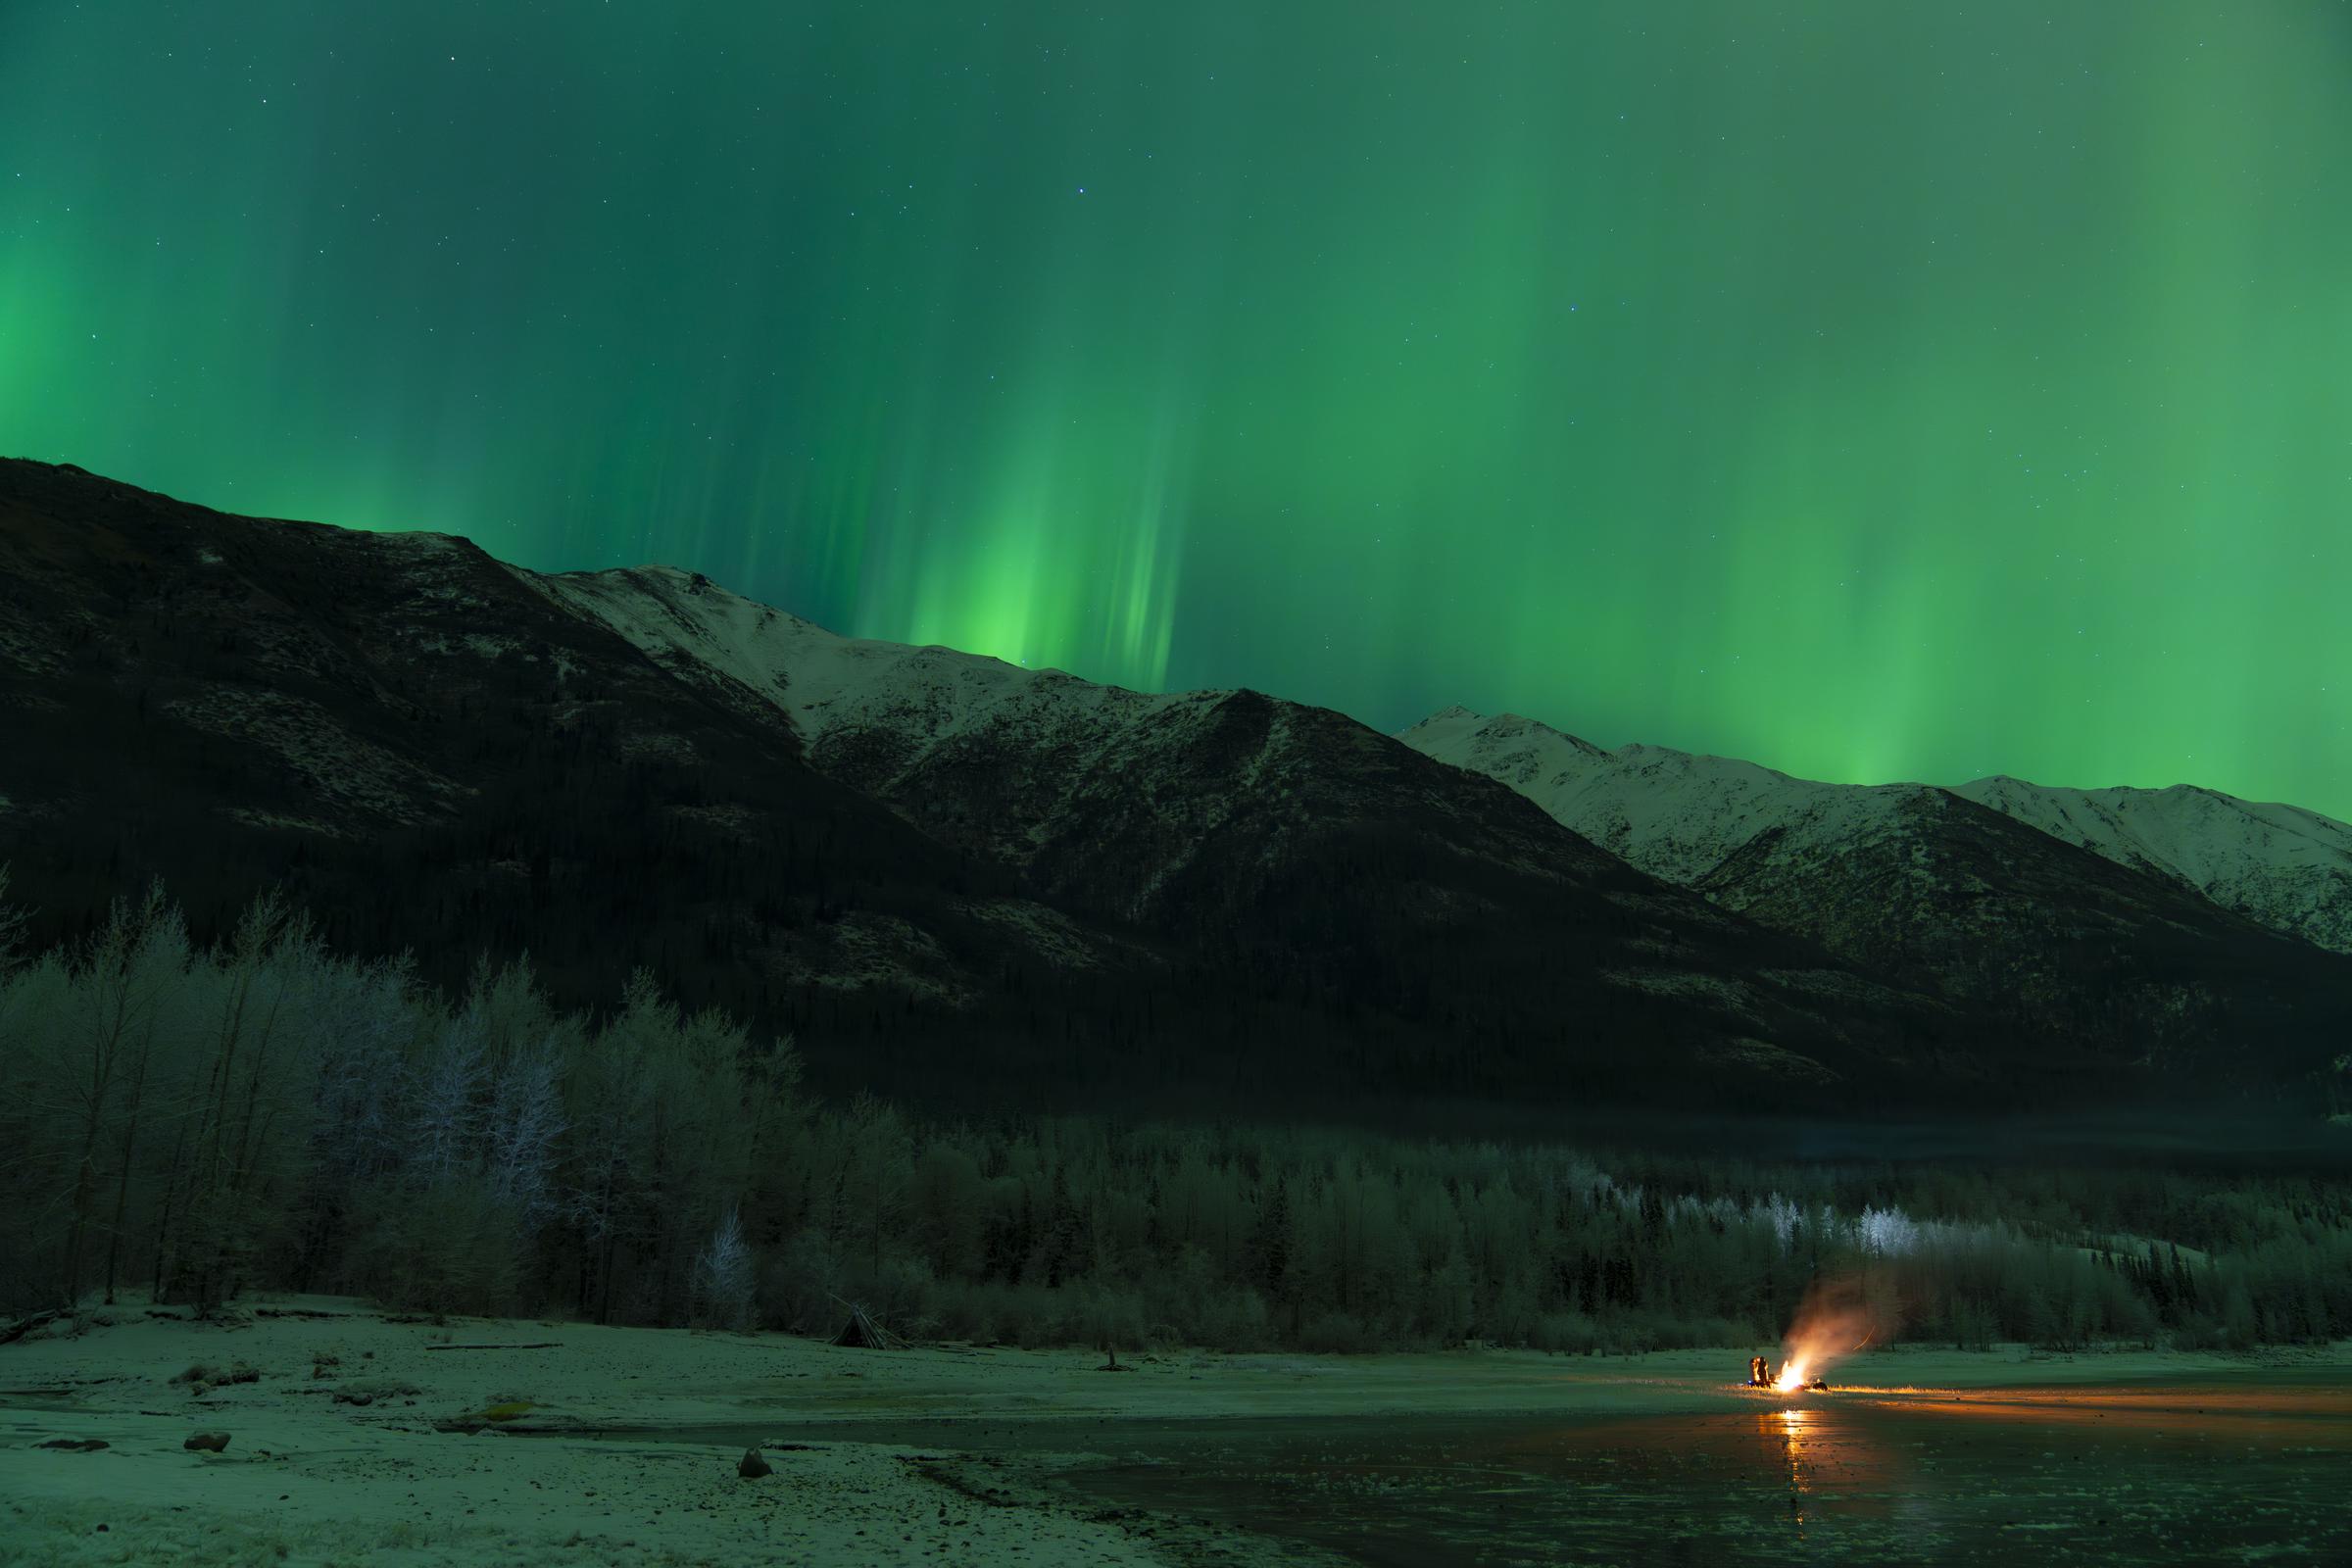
<box><xmin>0</xmin><ymin>1298</ymin><xmax>2345</xmax><ymax>1566</ymax></box>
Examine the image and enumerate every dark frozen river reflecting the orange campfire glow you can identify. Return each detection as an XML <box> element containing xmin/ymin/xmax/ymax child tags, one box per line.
<box><xmin>1072</xmin><ymin>1368</ymin><xmax>2352</xmax><ymax>1568</ymax></box>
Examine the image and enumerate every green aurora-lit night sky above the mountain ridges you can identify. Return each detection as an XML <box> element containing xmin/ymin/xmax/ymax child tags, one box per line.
<box><xmin>0</xmin><ymin>0</ymin><xmax>2352</xmax><ymax>815</ymax></box>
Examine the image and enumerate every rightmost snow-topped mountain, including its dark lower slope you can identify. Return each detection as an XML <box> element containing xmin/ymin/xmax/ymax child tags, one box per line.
<box><xmin>1404</xmin><ymin>710</ymin><xmax>2352</xmax><ymax>1079</ymax></box>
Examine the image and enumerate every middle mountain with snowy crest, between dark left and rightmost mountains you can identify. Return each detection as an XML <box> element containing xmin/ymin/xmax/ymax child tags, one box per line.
<box><xmin>529</xmin><ymin>566</ymin><xmax>2023</xmax><ymax>1104</ymax></box>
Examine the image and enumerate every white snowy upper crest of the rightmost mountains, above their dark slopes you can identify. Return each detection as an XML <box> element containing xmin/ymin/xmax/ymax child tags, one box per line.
<box><xmin>1401</xmin><ymin>708</ymin><xmax>2352</xmax><ymax>953</ymax></box>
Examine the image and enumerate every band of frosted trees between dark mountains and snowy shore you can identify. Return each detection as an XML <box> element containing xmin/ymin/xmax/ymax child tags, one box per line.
<box><xmin>0</xmin><ymin>891</ymin><xmax>2352</xmax><ymax>1351</ymax></box>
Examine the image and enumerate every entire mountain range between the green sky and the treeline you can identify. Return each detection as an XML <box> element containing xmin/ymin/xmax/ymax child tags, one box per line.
<box><xmin>14</xmin><ymin>461</ymin><xmax>2352</xmax><ymax>1112</ymax></box>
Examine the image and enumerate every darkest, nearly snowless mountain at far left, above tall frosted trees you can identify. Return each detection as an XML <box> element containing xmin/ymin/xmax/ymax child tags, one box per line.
<box><xmin>0</xmin><ymin>464</ymin><xmax>1096</xmax><ymax>1053</ymax></box>
